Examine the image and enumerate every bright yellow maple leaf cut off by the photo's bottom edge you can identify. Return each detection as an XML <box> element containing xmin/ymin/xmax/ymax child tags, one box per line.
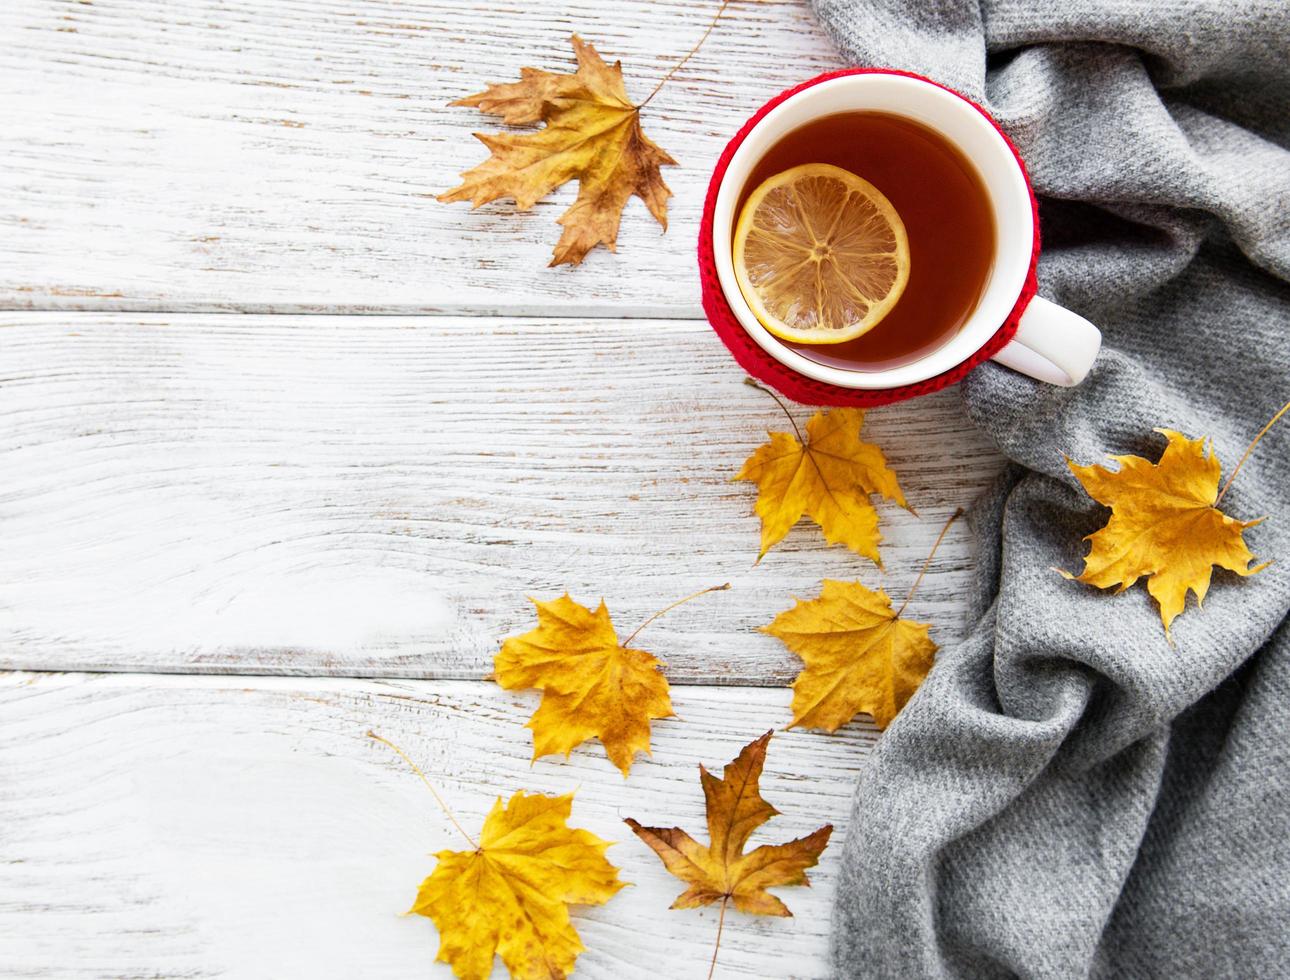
<box><xmin>410</xmin><ymin>790</ymin><xmax>626</xmax><ymax>980</ymax></box>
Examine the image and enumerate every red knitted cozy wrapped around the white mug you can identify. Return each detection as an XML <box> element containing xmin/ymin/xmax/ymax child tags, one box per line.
<box><xmin>699</xmin><ymin>68</ymin><xmax>1040</xmax><ymax>407</ymax></box>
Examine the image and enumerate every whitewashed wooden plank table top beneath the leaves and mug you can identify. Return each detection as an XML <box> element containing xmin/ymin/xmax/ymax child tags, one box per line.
<box><xmin>0</xmin><ymin>0</ymin><xmax>1000</xmax><ymax>980</ymax></box>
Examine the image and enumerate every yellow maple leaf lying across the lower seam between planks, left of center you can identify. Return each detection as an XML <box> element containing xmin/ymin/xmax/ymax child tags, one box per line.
<box><xmin>494</xmin><ymin>594</ymin><xmax>672</xmax><ymax>776</ymax></box>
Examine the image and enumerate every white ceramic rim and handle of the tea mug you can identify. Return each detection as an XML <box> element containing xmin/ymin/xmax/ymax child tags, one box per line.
<box><xmin>712</xmin><ymin>72</ymin><xmax>1102</xmax><ymax>389</ymax></box>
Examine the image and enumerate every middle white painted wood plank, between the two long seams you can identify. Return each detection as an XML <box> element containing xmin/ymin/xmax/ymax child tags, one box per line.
<box><xmin>0</xmin><ymin>313</ymin><xmax>1000</xmax><ymax>685</ymax></box>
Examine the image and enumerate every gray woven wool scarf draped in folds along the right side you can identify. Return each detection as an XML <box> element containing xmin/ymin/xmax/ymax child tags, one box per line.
<box><xmin>815</xmin><ymin>0</ymin><xmax>1290</xmax><ymax>980</ymax></box>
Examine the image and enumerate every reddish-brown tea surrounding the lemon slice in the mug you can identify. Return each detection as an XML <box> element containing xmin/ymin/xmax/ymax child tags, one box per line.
<box><xmin>735</xmin><ymin>112</ymin><xmax>995</xmax><ymax>370</ymax></box>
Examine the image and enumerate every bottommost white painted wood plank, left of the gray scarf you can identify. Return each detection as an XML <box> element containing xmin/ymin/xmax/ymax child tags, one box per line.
<box><xmin>0</xmin><ymin>674</ymin><xmax>876</xmax><ymax>980</ymax></box>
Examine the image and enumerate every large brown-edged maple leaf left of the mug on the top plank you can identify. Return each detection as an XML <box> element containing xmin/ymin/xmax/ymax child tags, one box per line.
<box><xmin>439</xmin><ymin>35</ymin><xmax>676</xmax><ymax>266</ymax></box>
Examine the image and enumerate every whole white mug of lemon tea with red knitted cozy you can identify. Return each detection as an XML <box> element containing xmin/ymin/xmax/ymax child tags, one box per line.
<box><xmin>699</xmin><ymin>68</ymin><xmax>1102</xmax><ymax>405</ymax></box>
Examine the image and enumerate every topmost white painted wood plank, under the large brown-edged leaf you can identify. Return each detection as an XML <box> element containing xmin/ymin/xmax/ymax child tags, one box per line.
<box><xmin>0</xmin><ymin>0</ymin><xmax>839</xmax><ymax>316</ymax></box>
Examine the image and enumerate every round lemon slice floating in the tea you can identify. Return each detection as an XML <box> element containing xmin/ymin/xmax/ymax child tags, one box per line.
<box><xmin>734</xmin><ymin>164</ymin><xmax>909</xmax><ymax>344</ymax></box>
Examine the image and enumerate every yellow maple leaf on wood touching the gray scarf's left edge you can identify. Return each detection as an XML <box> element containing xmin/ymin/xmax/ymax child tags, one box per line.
<box><xmin>761</xmin><ymin>579</ymin><xmax>937</xmax><ymax>731</ymax></box>
